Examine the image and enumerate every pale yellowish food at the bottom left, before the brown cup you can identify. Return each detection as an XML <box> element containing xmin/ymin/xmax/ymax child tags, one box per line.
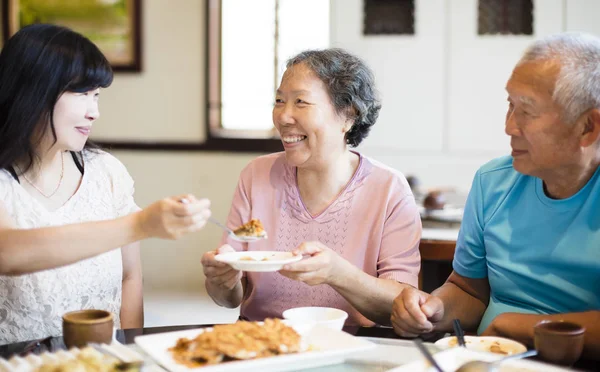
<box><xmin>36</xmin><ymin>347</ymin><xmax>139</xmax><ymax>372</ymax></box>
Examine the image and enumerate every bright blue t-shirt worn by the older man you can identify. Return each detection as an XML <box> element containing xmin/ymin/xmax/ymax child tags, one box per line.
<box><xmin>453</xmin><ymin>157</ymin><xmax>600</xmax><ymax>333</ymax></box>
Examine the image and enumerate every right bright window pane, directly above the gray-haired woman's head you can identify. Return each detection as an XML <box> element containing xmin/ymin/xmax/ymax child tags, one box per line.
<box><xmin>277</xmin><ymin>0</ymin><xmax>329</xmax><ymax>83</ymax></box>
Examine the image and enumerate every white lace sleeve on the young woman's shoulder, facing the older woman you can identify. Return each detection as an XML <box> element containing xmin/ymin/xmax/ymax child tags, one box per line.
<box><xmin>105</xmin><ymin>154</ymin><xmax>140</xmax><ymax>217</ymax></box>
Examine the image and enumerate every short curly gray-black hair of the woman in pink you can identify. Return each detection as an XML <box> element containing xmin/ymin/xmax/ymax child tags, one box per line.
<box><xmin>286</xmin><ymin>48</ymin><xmax>381</xmax><ymax>147</ymax></box>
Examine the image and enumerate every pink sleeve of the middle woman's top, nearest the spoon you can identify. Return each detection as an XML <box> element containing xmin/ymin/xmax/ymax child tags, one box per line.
<box><xmin>221</xmin><ymin>164</ymin><xmax>252</xmax><ymax>251</ymax></box>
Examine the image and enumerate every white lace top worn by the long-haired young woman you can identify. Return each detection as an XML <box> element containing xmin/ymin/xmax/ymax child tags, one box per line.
<box><xmin>0</xmin><ymin>152</ymin><xmax>138</xmax><ymax>344</ymax></box>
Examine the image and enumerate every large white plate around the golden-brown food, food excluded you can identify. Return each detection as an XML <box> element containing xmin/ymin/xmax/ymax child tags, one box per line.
<box><xmin>135</xmin><ymin>326</ymin><xmax>375</xmax><ymax>372</ymax></box>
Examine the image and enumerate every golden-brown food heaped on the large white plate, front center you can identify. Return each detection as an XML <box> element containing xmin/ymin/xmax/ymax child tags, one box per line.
<box><xmin>169</xmin><ymin>318</ymin><xmax>301</xmax><ymax>368</ymax></box>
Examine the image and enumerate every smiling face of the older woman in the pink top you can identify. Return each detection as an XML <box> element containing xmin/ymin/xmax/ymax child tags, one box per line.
<box><xmin>273</xmin><ymin>63</ymin><xmax>352</xmax><ymax>167</ymax></box>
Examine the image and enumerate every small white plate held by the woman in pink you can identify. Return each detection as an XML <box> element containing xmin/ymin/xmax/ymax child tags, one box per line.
<box><xmin>215</xmin><ymin>251</ymin><xmax>302</xmax><ymax>272</ymax></box>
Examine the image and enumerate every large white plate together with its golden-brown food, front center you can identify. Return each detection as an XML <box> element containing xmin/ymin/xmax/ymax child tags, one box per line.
<box><xmin>135</xmin><ymin>319</ymin><xmax>375</xmax><ymax>372</ymax></box>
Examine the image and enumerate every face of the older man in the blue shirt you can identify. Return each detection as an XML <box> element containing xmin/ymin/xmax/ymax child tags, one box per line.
<box><xmin>505</xmin><ymin>61</ymin><xmax>583</xmax><ymax>179</ymax></box>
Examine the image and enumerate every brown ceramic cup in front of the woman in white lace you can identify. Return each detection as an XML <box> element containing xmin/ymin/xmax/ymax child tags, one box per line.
<box><xmin>63</xmin><ymin>310</ymin><xmax>113</xmax><ymax>348</ymax></box>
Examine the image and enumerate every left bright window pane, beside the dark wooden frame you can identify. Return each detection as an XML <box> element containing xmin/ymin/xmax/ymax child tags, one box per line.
<box><xmin>221</xmin><ymin>0</ymin><xmax>275</xmax><ymax>129</ymax></box>
